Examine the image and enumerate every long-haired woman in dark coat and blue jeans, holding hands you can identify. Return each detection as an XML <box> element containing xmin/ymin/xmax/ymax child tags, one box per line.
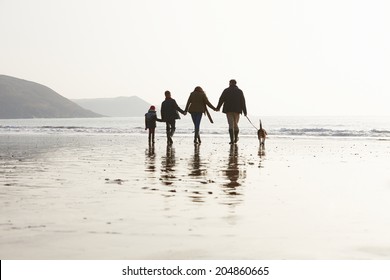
<box><xmin>184</xmin><ymin>87</ymin><xmax>216</xmax><ymax>144</ymax></box>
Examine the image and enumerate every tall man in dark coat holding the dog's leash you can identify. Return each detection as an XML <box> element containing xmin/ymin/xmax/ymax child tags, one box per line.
<box><xmin>217</xmin><ymin>80</ymin><xmax>247</xmax><ymax>144</ymax></box>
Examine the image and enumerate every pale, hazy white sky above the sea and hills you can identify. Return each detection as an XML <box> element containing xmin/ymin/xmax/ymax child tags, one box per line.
<box><xmin>0</xmin><ymin>0</ymin><xmax>390</xmax><ymax>116</ymax></box>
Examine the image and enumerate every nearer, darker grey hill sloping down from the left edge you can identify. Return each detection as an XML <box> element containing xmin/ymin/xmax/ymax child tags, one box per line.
<box><xmin>0</xmin><ymin>75</ymin><xmax>101</xmax><ymax>119</ymax></box>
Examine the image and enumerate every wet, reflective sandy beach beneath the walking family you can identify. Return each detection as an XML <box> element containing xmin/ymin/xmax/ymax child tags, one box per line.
<box><xmin>0</xmin><ymin>134</ymin><xmax>390</xmax><ymax>260</ymax></box>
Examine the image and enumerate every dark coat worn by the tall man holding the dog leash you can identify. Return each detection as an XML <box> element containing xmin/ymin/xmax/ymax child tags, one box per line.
<box><xmin>217</xmin><ymin>85</ymin><xmax>247</xmax><ymax>116</ymax></box>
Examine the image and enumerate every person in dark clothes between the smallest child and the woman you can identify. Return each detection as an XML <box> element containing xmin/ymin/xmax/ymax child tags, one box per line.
<box><xmin>161</xmin><ymin>90</ymin><xmax>186</xmax><ymax>145</ymax></box>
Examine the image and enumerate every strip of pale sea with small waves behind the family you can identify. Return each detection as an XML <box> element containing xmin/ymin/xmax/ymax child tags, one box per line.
<box><xmin>0</xmin><ymin>114</ymin><xmax>390</xmax><ymax>140</ymax></box>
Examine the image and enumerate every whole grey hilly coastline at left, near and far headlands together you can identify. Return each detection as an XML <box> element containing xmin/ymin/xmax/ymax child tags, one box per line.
<box><xmin>0</xmin><ymin>75</ymin><xmax>150</xmax><ymax>119</ymax></box>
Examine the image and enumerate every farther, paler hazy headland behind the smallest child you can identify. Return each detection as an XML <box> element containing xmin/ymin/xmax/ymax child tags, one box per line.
<box><xmin>72</xmin><ymin>96</ymin><xmax>150</xmax><ymax>117</ymax></box>
